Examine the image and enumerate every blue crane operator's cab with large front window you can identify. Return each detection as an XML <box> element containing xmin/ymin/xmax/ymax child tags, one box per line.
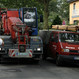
<box><xmin>19</xmin><ymin>7</ymin><xmax>38</xmax><ymax>36</ymax></box>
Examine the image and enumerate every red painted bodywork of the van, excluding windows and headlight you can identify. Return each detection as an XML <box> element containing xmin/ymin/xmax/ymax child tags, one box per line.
<box><xmin>49</xmin><ymin>31</ymin><xmax>79</xmax><ymax>58</ymax></box>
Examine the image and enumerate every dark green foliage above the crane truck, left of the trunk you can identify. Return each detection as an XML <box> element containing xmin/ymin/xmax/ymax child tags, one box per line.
<box><xmin>0</xmin><ymin>0</ymin><xmax>43</xmax><ymax>14</ymax></box>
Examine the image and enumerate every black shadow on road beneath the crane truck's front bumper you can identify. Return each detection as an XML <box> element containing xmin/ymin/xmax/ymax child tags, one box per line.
<box><xmin>1</xmin><ymin>59</ymin><xmax>40</xmax><ymax>66</ymax></box>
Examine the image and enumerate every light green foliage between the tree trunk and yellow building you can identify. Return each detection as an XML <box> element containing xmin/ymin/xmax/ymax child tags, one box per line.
<box><xmin>48</xmin><ymin>0</ymin><xmax>69</xmax><ymax>26</ymax></box>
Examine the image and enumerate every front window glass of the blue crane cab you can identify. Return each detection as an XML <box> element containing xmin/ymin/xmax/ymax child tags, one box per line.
<box><xmin>24</xmin><ymin>9</ymin><xmax>36</xmax><ymax>27</ymax></box>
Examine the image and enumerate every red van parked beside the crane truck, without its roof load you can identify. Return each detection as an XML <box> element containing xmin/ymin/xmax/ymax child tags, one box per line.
<box><xmin>39</xmin><ymin>27</ymin><xmax>79</xmax><ymax>65</ymax></box>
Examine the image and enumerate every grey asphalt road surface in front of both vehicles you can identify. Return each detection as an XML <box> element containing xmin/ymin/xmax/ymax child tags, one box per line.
<box><xmin>0</xmin><ymin>59</ymin><xmax>79</xmax><ymax>79</ymax></box>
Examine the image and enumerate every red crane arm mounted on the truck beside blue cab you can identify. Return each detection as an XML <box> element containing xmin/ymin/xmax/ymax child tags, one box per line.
<box><xmin>2</xmin><ymin>11</ymin><xmax>29</xmax><ymax>49</ymax></box>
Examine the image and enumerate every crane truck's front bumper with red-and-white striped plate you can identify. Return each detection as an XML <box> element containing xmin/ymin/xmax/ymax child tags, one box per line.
<box><xmin>3</xmin><ymin>49</ymin><xmax>43</xmax><ymax>58</ymax></box>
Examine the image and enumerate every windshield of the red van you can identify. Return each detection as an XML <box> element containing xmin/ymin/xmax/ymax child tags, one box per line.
<box><xmin>60</xmin><ymin>33</ymin><xmax>79</xmax><ymax>43</ymax></box>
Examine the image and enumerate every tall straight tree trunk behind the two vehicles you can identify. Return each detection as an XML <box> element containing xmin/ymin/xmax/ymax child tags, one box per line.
<box><xmin>43</xmin><ymin>0</ymin><xmax>49</xmax><ymax>29</ymax></box>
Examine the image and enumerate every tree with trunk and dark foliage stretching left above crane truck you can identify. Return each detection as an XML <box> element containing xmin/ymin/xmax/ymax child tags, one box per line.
<box><xmin>1</xmin><ymin>0</ymin><xmax>56</xmax><ymax>29</ymax></box>
